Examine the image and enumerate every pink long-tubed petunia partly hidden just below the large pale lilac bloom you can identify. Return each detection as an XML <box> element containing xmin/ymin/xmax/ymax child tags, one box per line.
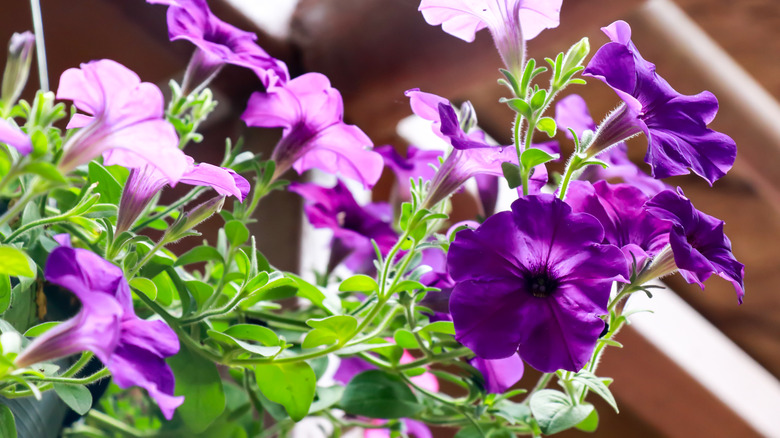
<box><xmin>116</xmin><ymin>157</ymin><xmax>250</xmax><ymax>234</ymax></box>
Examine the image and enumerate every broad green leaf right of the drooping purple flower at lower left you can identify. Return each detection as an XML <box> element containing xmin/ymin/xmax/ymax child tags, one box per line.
<box><xmin>167</xmin><ymin>344</ymin><xmax>225</xmax><ymax>433</ymax></box>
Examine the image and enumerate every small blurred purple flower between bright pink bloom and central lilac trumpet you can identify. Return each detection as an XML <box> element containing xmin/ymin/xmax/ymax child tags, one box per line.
<box><xmin>374</xmin><ymin>145</ymin><xmax>444</xmax><ymax>200</ymax></box>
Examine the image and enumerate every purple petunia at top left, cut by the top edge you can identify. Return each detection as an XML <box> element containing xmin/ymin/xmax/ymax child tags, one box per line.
<box><xmin>147</xmin><ymin>0</ymin><xmax>290</xmax><ymax>90</ymax></box>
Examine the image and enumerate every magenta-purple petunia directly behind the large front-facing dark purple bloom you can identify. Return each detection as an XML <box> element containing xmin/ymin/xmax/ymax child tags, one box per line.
<box><xmin>566</xmin><ymin>181</ymin><xmax>670</xmax><ymax>270</ymax></box>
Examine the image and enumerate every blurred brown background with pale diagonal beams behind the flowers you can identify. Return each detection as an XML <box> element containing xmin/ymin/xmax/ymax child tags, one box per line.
<box><xmin>0</xmin><ymin>0</ymin><xmax>780</xmax><ymax>437</ymax></box>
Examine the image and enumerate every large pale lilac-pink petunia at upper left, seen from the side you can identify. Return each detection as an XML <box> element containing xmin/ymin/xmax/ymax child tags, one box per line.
<box><xmin>57</xmin><ymin>59</ymin><xmax>188</xmax><ymax>184</ymax></box>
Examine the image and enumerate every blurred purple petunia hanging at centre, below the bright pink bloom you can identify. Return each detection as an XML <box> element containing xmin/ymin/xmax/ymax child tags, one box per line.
<box><xmin>289</xmin><ymin>181</ymin><xmax>398</xmax><ymax>272</ymax></box>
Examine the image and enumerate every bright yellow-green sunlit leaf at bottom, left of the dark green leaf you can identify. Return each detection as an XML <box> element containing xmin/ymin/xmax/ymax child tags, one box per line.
<box><xmin>255</xmin><ymin>362</ymin><xmax>317</xmax><ymax>421</ymax></box>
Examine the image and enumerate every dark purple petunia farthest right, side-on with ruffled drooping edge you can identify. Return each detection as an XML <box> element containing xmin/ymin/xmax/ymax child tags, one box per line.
<box><xmin>645</xmin><ymin>189</ymin><xmax>745</xmax><ymax>304</ymax></box>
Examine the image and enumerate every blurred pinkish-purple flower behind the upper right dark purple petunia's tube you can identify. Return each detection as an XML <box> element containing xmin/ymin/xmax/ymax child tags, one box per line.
<box><xmin>555</xmin><ymin>94</ymin><xmax>669</xmax><ymax>196</ymax></box>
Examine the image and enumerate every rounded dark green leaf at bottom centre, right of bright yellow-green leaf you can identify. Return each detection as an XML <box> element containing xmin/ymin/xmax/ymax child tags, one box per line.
<box><xmin>341</xmin><ymin>370</ymin><xmax>423</xmax><ymax>418</ymax></box>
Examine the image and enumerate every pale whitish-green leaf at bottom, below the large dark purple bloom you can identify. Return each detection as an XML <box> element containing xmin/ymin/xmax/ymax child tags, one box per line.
<box><xmin>530</xmin><ymin>389</ymin><xmax>593</xmax><ymax>435</ymax></box>
